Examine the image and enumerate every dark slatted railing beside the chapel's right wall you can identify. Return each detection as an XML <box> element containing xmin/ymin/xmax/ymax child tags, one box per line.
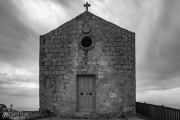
<box><xmin>136</xmin><ymin>102</ymin><xmax>180</xmax><ymax>120</ymax></box>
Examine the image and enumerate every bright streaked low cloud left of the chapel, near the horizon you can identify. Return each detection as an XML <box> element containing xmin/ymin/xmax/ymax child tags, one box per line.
<box><xmin>0</xmin><ymin>64</ymin><xmax>39</xmax><ymax>97</ymax></box>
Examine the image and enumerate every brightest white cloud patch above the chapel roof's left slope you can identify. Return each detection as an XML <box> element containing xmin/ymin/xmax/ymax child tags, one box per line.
<box><xmin>12</xmin><ymin>0</ymin><xmax>67</xmax><ymax>32</ymax></box>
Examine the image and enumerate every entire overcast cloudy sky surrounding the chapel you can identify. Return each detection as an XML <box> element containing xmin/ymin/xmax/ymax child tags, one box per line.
<box><xmin>0</xmin><ymin>0</ymin><xmax>180</xmax><ymax>110</ymax></box>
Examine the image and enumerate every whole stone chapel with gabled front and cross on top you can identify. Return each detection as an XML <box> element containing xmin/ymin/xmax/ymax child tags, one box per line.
<box><xmin>39</xmin><ymin>3</ymin><xmax>136</xmax><ymax>116</ymax></box>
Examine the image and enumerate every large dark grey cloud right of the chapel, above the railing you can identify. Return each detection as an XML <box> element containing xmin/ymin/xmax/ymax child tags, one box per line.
<box><xmin>137</xmin><ymin>0</ymin><xmax>180</xmax><ymax>89</ymax></box>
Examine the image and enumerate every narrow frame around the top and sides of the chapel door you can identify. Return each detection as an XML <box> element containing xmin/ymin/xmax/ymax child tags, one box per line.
<box><xmin>76</xmin><ymin>74</ymin><xmax>96</xmax><ymax>112</ymax></box>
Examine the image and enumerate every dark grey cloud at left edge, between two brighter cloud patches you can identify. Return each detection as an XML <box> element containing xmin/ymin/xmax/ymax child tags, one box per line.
<box><xmin>0</xmin><ymin>0</ymin><xmax>38</xmax><ymax>68</ymax></box>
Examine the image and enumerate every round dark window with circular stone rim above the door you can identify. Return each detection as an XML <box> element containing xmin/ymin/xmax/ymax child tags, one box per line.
<box><xmin>79</xmin><ymin>36</ymin><xmax>94</xmax><ymax>50</ymax></box>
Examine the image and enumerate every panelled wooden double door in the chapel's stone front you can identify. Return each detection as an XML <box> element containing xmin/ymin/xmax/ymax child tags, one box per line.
<box><xmin>77</xmin><ymin>75</ymin><xmax>95</xmax><ymax>112</ymax></box>
